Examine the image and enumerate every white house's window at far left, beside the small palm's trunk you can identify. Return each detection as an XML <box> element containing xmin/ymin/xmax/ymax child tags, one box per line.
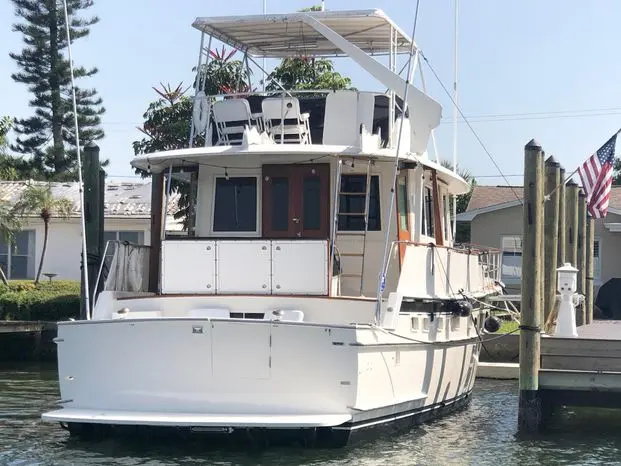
<box><xmin>0</xmin><ymin>230</ymin><xmax>35</xmax><ymax>280</ymax></box>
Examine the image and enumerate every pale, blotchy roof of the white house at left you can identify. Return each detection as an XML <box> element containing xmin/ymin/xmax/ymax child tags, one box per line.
<box><xmin>0</xmin><ymin>181</ymin><xmax>179</xmax><ymax>218</ymax></box>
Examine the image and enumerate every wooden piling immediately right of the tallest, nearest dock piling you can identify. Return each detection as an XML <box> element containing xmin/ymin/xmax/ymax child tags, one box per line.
<box><xmin>543</xmin><ymin>156</ymin><xmax>561</xmax><ymax>322</ymax></box>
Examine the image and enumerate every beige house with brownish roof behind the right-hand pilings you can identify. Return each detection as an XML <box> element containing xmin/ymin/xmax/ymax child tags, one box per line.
<box><xmin>457</xmin><ymin>186</ymin><xmax>621</xmax><ymax>290</ymax></box>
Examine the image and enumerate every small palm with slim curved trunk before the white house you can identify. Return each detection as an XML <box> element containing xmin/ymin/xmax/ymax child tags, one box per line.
<box><xmin>13</xmin><ymin>184</ymin><xmax>73</xmax><ymax>284</ymax></box>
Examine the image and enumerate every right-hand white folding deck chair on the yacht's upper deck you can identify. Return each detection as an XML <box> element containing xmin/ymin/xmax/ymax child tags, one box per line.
<box><xmin>261</xmin><ymin>96</ymin><xmax>311</xmax><ymax>144</ymax></box>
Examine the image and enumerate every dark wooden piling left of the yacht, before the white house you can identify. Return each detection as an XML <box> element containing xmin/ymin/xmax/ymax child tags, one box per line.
<box><xmin>80</xmin><ymin>142</ymin><xmax>104</xmax><ymax>319</ymax></box>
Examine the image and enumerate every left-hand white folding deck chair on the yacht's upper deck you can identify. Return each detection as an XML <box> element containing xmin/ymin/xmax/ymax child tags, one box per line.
<box><xmin>213</xmin><ymin>99</ymin><xmax>252</xmax><ymax>146</ymax></box>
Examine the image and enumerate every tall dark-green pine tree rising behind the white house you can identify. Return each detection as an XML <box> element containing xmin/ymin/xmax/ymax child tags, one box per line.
<box><xmin>10</xmin><ymin>0</ymin><xmax>107</xmax><ymax>180</ymax></box>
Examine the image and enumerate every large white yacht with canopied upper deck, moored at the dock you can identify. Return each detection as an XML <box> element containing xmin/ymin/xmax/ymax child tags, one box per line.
<box><xmin>43</xmin><ymin>10</ymin><xmax>499</xmax><ymax>446</ymax></box>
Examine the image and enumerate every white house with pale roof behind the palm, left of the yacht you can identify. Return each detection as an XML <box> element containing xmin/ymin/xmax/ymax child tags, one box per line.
<box><xmin>0</xmin><ymin>181</ymin><xmax>179</xmax><ymax>280</ymax></box>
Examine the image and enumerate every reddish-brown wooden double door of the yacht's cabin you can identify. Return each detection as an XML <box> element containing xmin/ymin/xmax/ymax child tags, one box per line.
<box><xmin>262</xmin><ymin>164</ymin><xmax>330</xmax><ymax>239</ymax></box>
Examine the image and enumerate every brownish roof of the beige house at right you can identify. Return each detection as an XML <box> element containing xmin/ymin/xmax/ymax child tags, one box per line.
<box><xmin>457</xmin><ymin>185</ymin><xmax>621</xmax><ymax>222</ymax></box>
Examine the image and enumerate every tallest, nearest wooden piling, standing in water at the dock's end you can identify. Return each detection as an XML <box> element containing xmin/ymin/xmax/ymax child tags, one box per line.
<box><xmin>518</xmin><ymin>139</ymin><xmax>543</xmax><ymax>433</ymax></box>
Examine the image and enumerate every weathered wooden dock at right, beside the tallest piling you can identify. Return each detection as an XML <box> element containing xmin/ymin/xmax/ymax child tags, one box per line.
<box><xmin>539</xmin><ymin>321</ymin><xmax>621</xmax><ymax>412</ymax></box>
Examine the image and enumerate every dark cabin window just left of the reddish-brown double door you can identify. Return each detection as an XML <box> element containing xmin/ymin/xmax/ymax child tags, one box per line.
<box><xmin>213</xmin><ymin>176</ymin><xmax>257</xmax><ymax>233</ymax></box>
